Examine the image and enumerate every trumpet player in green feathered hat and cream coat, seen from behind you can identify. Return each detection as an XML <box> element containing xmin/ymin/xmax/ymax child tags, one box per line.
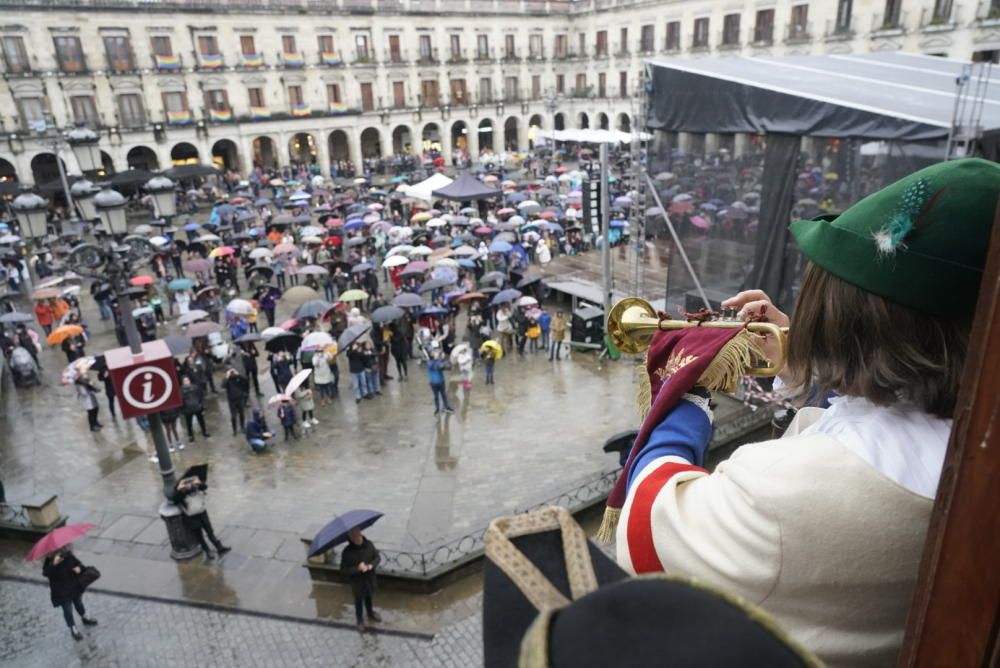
<box><xmin>602</xmin><ymin>159</ymin><xmax>1000</xmax><ymax>667</ymax></box>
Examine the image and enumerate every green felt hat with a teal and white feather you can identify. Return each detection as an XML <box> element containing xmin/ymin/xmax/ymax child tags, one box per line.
<box><xmin>791</xmin><ymin>158</ymin><xmax>1000</xmax><ymax>318</ymax></box>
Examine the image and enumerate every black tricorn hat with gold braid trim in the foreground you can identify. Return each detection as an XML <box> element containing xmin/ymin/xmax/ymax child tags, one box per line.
<box><xmin>483</xmin><ymin>508</ymin><xmax>822</xmax><ymax>668</ymax></box>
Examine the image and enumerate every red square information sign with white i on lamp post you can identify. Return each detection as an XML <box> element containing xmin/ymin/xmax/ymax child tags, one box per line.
<box><xmin>104</xmin><ymin>340</ymin><xmax>181</xmax><ymax>419</ymax></box>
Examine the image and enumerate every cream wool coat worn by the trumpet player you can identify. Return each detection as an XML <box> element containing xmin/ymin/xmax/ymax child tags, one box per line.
<box><xmin>617</xmin><ymin>411</ymin><xmax>933</xmax><ymax>668</ymax></box>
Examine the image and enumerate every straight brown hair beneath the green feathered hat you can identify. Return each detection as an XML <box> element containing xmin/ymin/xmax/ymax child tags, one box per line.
<box><xmin>788</xmin><ymin>263</ymin><xmax>971</xmax><ymax>418</ymax></box>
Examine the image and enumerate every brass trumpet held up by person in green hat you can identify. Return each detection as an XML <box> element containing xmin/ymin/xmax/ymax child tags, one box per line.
<box><xmin>607</xmin><ymin>297</ymin><xmax>788</xmax><ymax>376</ymax></box>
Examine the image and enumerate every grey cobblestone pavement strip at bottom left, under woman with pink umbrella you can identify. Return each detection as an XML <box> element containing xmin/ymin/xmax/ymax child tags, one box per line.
<box><xmin>0</xmin><ymin>580</ymin><xmax>482</xmax><ymax>668</ymax></box>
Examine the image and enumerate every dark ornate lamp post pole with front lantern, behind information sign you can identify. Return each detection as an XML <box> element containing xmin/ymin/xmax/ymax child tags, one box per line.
<box><xmin>66</xmin><ymin>188</ymin><xmax>201</xmax><ymax>560</ymax></box>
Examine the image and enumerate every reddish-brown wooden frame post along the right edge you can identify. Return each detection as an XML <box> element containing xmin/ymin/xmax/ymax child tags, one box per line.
<box><xmin>897</xmin><ymin>207</ymin><xmax>1000</xmax><ymax>668</ymax></box>
